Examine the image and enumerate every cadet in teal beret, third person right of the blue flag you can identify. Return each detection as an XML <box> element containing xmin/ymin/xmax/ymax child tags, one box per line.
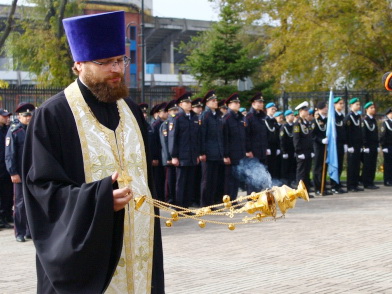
<box><xmin>362</xmin><ymin>102</ymin><xmax>381</xmax><ymax>190</ymax></box>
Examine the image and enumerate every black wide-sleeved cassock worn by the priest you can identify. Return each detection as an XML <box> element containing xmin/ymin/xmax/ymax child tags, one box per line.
<box><xmin>22</xmin><ymin>80</ymin><xmax>164</xmax><ymax>294</ymax></box>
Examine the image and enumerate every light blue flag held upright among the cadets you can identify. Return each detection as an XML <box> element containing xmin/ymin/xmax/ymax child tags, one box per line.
<box><xmin>327</xmin><ymin>90</ymin><xmax>339</xmax><ymax>183</ymax></box>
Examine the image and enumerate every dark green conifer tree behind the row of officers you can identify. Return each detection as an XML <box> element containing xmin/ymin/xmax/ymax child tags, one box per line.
<box><xmin>180</xmin><ymin>1</ymin><xmax>261</xmax><ymax>87</ymax></box>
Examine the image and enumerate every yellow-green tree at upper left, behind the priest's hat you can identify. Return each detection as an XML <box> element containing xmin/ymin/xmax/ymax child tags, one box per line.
<box><xmin>6</xmin><ymin>0</ymin><xmax>79</xmax><ymax>87</ymax></box>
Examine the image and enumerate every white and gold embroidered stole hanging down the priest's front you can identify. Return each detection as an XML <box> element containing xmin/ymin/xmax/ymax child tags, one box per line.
<box><xmin>64</xmin><ymin>82</ymin><xmax>154</xmax><ymax>294</ymax></box>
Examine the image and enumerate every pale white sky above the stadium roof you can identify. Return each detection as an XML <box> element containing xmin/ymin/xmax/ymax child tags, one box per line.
<box><xmin>0</xmin><ymin>0</ymin><xmax>219</xmax><ymax>21</ymax></box>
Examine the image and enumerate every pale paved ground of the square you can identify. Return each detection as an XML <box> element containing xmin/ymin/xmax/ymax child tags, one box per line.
<box><xmin>0</xmin><ymin>186</ymin><xmax>392</xmax><ymax>294</ymax></box>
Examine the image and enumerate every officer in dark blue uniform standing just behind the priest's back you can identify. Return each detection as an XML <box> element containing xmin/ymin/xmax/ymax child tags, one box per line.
<box><xmin>5</xmin><ymin>102</ymin><xmax>35</xmax><ymax>242</ymax></box>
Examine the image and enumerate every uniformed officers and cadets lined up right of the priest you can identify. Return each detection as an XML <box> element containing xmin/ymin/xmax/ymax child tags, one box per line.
<box><xmin>139</xmin><ymin>90</ymin><xmax>392</xmax><ymax>207</ymax></box>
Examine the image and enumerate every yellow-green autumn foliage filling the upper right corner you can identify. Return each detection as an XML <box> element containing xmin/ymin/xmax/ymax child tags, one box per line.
<box><xmin>241</xmin><ymin>0</ymin><xmax>392</xmax><ymax>91</ymax></box>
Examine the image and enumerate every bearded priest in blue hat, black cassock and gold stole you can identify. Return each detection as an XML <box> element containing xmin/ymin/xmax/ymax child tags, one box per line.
<box><xmin>22</xmin><ymin>11</ymin><xmax>164</xmax><ymax>293</ymax></box>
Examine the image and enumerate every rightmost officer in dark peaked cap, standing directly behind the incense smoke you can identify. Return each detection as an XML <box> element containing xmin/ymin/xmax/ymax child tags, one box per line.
<box><xmin>246</xmin><ymin>92</ymin><xmax>268</xmax><ymax>194</ymax></box>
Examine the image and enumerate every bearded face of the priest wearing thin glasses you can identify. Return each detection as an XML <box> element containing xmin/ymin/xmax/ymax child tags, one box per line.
<box><xmin>75</xmin><ymin>56</ymin><xmax>128</xmax><ymax>103</ymax></box>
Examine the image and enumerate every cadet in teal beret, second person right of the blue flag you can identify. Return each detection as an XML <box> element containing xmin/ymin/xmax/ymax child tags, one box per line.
<box><xmin>343</xmin><ymin>98</ymin><xmax>363</xmax><ymax>192</ymax></box>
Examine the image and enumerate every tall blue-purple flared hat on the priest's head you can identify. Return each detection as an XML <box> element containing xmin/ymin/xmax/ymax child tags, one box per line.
<box><xmin>63</xmin><ymin>11</ymin><xmax>125</xmax><ymax>61</ymax></box>
